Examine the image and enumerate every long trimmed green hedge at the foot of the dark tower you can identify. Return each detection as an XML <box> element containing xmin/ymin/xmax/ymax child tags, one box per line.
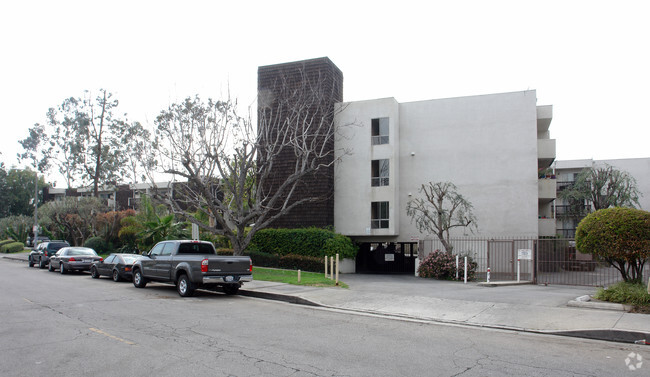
<box><xmin>248</xmin><ymin>228</ymin><xmax>357</xmax><ymax>259</ymax></box>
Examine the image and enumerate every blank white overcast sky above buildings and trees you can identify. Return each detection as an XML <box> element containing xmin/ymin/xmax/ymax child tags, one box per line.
<box><xmin>0</xmin><ymin>0</ymin><xmax>650</xmax><ymax>187</ymax></box>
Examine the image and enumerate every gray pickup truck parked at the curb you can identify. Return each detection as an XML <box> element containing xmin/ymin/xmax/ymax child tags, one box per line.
<box><xmin>133</xmin><ymin>240</ymin><xmax>253</xmax><ymax>297</ymax></box>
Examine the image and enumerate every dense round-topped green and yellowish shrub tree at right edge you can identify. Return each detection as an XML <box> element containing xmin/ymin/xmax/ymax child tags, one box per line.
<box><xmin>576</xmin><ymin>207</ymin><xmax>650</xmax><ymax>283</ymax></box>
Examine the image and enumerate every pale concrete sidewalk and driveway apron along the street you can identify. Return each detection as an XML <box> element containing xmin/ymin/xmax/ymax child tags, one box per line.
<box><xmin>3</xmin><ymin>253</ymin><xmax>650</xmax><ymax>343</ymax></box>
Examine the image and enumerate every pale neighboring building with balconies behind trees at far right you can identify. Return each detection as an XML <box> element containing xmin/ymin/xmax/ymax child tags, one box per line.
<box><xmin>553</xmin><ymin>158</ymin><xmax>650</xmax><ymax>238</ymax></box>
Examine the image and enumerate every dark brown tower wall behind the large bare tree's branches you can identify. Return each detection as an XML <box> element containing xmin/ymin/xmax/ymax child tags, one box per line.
<box><xmin>257</xmin><ymin>57</ymin><xmax>343</xmax><ymax>228</ymax></box>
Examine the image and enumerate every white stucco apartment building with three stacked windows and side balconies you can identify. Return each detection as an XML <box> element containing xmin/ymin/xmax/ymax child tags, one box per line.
<box><xmin>334</xmin><ymin>90</ymin><xmax>556</xmax><ymax>251</ymax></box>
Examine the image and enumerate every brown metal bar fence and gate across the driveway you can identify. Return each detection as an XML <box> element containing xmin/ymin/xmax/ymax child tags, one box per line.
<box><xmin>418</xmin><ymin>237</ymin><xmax>650</xmax><ymax>286</ymax></box>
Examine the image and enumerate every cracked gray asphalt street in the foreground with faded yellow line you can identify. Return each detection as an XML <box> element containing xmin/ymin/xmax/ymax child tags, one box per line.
<box><xmin>0</xmin><ymin>259</ymin><xmax>650</xmax><ymax>376</ymax></box>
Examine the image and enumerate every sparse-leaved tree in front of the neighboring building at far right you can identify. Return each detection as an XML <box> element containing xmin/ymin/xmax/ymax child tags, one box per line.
<box><xmin>560</xmin><ymin>165</ymin><xmax>641</xmax><ymax>211</ymax></box>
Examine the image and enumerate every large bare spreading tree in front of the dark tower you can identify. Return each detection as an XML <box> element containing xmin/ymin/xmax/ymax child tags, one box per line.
<box><xmin>156</xmin><ymin>75</ymin><xmax>346</xmax><ymax>255</ymax></box>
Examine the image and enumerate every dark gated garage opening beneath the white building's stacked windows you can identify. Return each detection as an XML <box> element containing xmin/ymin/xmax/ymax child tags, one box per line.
<box><xmin>356</xmin><ymin>242</ymin><xmax>417</xmax><ymax>274</ymax></box>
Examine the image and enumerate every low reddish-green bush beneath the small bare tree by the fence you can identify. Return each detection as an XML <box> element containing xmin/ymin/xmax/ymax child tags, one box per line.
<box><xmin>418</xmin><ymin>250</ymin><xmax>478</xmax><ymax>280</ymax></box>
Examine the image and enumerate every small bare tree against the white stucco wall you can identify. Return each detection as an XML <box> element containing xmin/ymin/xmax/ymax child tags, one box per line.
<box><xmin>406</xmin><ymin>182</ymin><xmax>477</xmax><ymax>253</ymax></box>
